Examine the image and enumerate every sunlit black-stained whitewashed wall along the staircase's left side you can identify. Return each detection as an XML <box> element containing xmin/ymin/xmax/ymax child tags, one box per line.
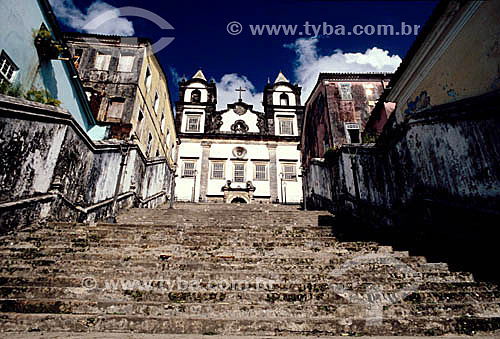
<box><xmin>0</xmin><ymin>96</ymin><xmax>170</xmax><ymax>232</ymax></box>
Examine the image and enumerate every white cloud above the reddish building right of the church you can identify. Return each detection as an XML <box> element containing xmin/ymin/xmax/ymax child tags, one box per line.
<box><xmin>285</xmin><ymin>38</ymin><xmax>401</xmax><ymax>102</ymax></box>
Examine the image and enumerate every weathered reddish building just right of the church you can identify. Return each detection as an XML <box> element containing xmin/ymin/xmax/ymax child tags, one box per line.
<box><xmin>302</xmin><ymin>73</ymin><xmax>391</xmax><ymax>163</ymax></box>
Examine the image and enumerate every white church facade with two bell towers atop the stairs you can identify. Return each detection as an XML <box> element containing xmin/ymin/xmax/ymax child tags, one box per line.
<box><xmin>175</xmin><ymin>70</ymin><xmax>304</xmax><ymax>203</ymax></box>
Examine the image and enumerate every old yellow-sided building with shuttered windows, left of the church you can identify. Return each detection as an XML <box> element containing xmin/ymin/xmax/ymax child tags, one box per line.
<box><xmin>64</xmin><ymin>33</ymin><xmax>176</xmax><ymax>167</ymax></box>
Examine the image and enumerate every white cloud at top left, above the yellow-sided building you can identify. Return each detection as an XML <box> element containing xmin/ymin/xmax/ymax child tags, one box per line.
<box><xmin>49</xmin><ymin>0</ymin><xmax>134</xmax><ymax>36</ymax></box>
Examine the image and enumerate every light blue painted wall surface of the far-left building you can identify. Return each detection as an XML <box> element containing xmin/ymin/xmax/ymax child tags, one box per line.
<box><xmin>0</xmin><ymin>0</ymin><xmax>106</xmax><ymax>140</ymax></box>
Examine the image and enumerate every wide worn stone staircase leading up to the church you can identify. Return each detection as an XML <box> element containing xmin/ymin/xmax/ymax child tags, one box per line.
<box><xmin>0</xmin><ymin>204</ymin><xmax>500</xmax><ymax>336</ymax></box>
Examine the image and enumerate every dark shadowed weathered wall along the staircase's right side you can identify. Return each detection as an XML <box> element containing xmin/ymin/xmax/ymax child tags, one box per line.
<box><xmin>306</xmin><ymin>91</ymin><xmax>500</xmax><ymax>279</ymax></box>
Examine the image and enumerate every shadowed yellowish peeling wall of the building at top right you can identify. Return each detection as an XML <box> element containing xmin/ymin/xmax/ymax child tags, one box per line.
<box><xmin>388</xmin><ymin>1</ymin><xmax>500</xmax><ymax>121</ymax></box>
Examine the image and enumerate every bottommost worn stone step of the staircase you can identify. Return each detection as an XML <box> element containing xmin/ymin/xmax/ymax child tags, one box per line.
<box><xmin>0</xmin><ymin>313</ymin><xmax>500</xmax><ymax>336</ymax></box>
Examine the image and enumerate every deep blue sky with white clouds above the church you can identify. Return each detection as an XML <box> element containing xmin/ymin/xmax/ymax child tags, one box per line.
<box><xmin>50</xmin><ymin>0</ymin><xmax>437</xmax><ymax>109</ymax></box>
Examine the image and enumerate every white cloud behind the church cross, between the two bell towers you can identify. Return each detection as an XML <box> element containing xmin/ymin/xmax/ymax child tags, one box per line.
<box><xmin>215</xmin><ymin>73</ymin><xmax>264</xmax><ymax>112</ymax></box>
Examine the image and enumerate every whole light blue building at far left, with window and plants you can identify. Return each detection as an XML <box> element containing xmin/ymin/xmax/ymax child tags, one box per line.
<box><xmin>0</xmin><ymin>0</ymin><xmax>107</xmax><ymax>140</ymax></box>
